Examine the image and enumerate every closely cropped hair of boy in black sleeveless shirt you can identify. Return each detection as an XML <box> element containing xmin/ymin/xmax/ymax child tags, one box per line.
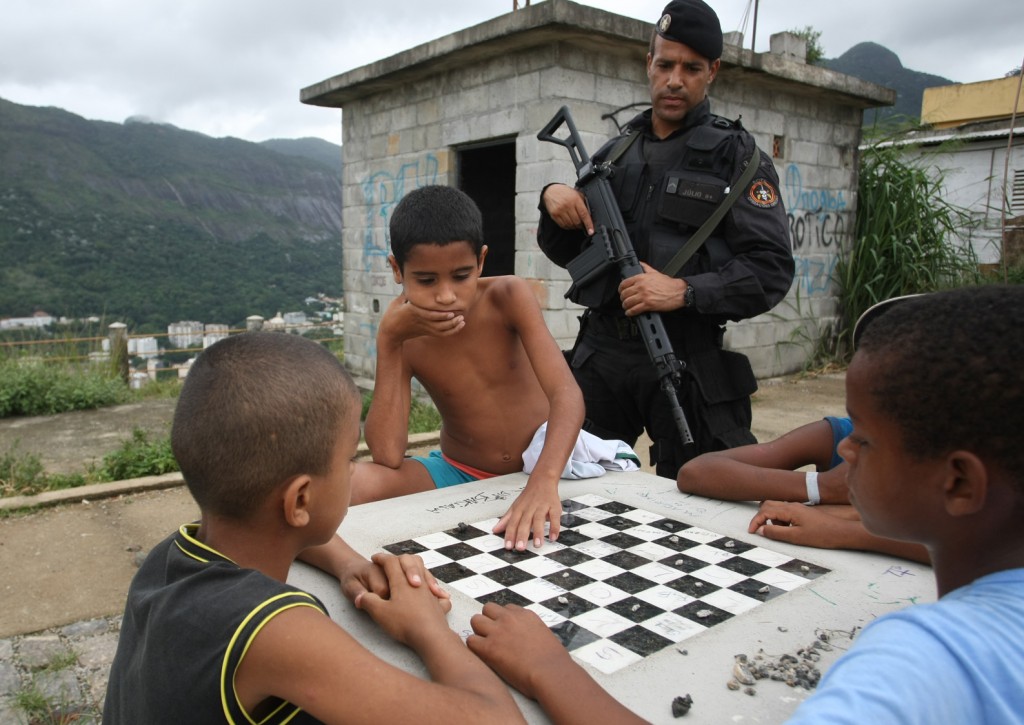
<box><xmin>171</xmin><ymin>332</ymin><xmax>359</xmax><ymax>520</ymax></box>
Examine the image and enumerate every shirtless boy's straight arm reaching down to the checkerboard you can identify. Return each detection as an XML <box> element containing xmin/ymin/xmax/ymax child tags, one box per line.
<box><xmin>495</xmin><ymin>279</ymin><xmax>584</xmax><ymax>550</ymax></box>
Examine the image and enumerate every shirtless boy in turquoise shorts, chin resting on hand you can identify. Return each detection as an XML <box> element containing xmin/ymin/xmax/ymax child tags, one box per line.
<box><xmin>352</xmin><ymin>186</ymin><xmax>584</xmax><ymax>550</ymax></box>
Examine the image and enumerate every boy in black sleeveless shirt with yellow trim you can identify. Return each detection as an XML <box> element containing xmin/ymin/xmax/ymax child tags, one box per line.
<box><xmin>103</xmin><ymin>333</ymin><xmax>522</xmax><ymax>725</ymax></box>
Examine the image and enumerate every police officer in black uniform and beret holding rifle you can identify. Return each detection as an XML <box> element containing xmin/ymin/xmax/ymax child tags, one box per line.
<box><xmin>538</xmin><ymin>0</ymin><xmax>794</xmax><ymax>478</ymax></box>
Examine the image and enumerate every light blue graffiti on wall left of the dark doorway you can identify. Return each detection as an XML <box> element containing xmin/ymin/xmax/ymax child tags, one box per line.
<box><xmin>359</xmin><ymin>154</ymin><xmax>440</xmax><ymax>272</ymax></box>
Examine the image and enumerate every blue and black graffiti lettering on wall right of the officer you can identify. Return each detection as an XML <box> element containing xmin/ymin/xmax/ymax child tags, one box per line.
<box><xmin>782</xmin><ymin>164</ymin><xmax>853</xmax><ymax>296</ymax></box>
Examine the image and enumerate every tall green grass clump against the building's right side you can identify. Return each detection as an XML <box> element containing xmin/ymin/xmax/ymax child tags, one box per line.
<box><xmin>831</xmin><ymin>141</ymin><xmax>981</xmax><ymax>359</ymax></box>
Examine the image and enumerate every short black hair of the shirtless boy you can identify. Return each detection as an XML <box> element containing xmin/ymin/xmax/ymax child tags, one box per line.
<box><xmin>390</xmin><ymin>185</ymin><xmax>483</xmax><ymax>269</ymax></box>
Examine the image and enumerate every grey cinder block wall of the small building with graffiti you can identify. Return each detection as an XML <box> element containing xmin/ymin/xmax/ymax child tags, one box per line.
<box><xmin>342</xmin><ymin>30</ymin><xmax>863</xmax><ymax>378</ymax></box>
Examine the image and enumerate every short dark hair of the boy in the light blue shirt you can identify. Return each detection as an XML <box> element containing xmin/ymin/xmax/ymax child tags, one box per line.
<box><xmin>857</xmin><ymin>285</ymin><xmax>1024</xmax><ymax>487</ymax></box>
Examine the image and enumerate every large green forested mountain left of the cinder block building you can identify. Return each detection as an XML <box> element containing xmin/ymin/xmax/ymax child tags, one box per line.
<box><xmin>0</xmin><ymin>99</ymin><xmax>341</xmax><ymax>332</ymax></box>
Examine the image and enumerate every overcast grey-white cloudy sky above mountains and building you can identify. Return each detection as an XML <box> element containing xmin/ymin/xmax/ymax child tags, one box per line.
<box><xmin>0</xmin><ymin>0</ymin><xmax>1024</xmax><ymax>143</ymax></box>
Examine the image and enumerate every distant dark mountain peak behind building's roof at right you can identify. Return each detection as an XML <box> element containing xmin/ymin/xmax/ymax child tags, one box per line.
<box><xmin>819</xmin><ymin>43</ymin><xmax>953</xmax><ymax>126</ymax></box>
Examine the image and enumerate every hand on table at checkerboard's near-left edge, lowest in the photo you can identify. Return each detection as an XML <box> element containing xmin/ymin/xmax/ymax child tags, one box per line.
<box><xmin>466</xmin><ymin>602</ymin><xmax>574</xmax><ymax>699</ymax></box>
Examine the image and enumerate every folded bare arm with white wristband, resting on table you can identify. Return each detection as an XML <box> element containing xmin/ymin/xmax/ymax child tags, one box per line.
<box><xmin>676</xmin><ymin>420</ymin><xmax>849</xmax><ymax>504</ymax></box>
